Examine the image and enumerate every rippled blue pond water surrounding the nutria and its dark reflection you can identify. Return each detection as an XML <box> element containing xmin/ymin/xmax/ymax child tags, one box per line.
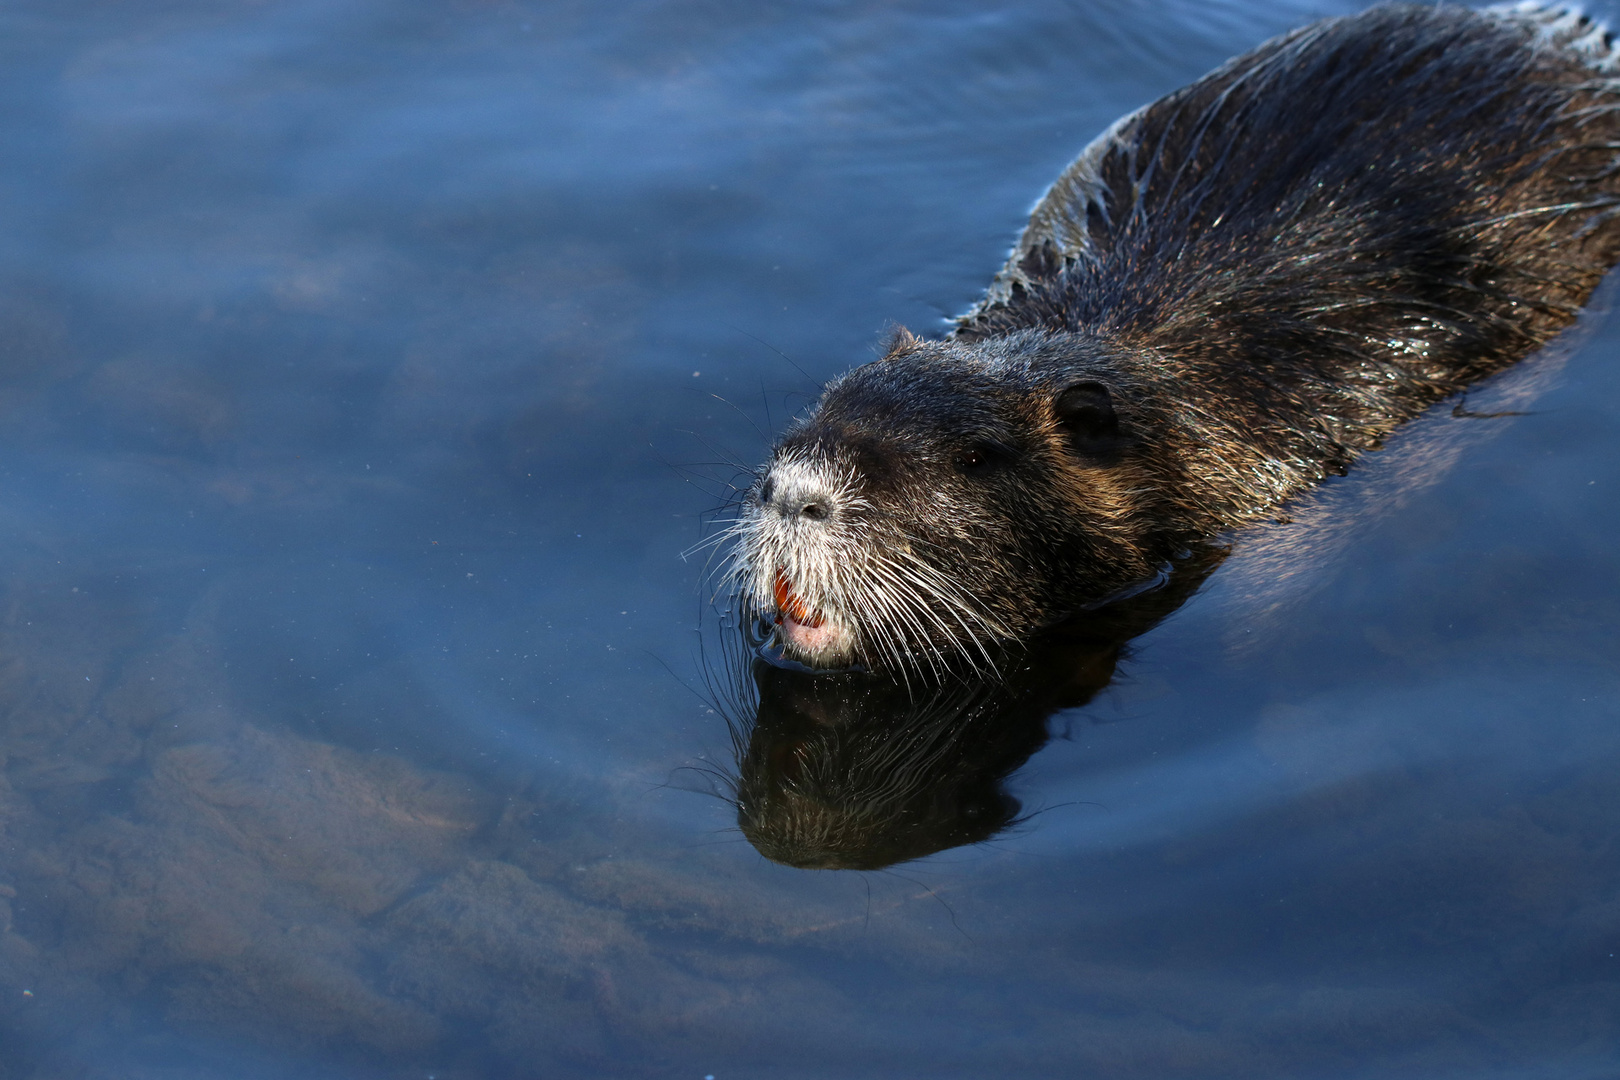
<box><xmin>0</xmin><ymin>0</ymin><xmax>1620</xmax><ymax>1080</ymax></box>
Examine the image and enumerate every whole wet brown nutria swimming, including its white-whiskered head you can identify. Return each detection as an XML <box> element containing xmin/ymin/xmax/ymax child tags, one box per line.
<box><xmin>737</xmin><ymin>5</ymin><xmax>1620</xmax><ymax>667</ymax></box>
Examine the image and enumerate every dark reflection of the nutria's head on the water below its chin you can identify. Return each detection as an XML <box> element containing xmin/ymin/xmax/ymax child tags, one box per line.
<box><xmin>734</xmin><ymin>547</ymin><xmax>1225</xmax><ymax>870</ymax></box>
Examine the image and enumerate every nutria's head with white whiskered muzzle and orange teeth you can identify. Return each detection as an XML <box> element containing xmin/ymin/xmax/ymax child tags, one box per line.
<box><xmin>735</xmin><ymin>330</ymin><xmax>1162</xmax><ymax>670</ymax></box>
